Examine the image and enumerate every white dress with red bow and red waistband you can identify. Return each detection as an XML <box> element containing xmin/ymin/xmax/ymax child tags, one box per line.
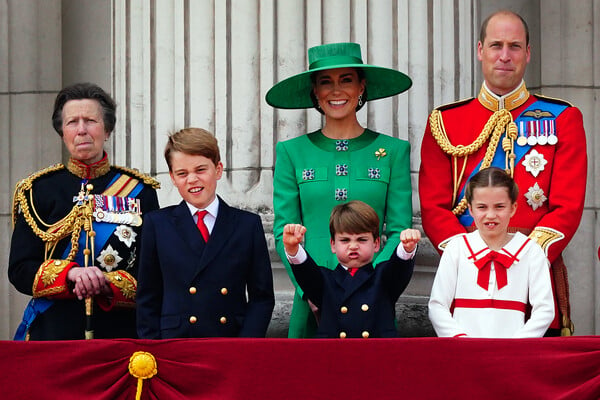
<box><xmin>429</xmin><ymin>231</ymin><xmax>554</xmax><ymax>338</ymax></box>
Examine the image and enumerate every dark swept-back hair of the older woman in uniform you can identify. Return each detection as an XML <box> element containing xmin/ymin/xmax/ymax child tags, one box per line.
<box><xmin>52</xmin><ymin>82</ymin><xmax>117</xmax><ymax>137</ymax></box>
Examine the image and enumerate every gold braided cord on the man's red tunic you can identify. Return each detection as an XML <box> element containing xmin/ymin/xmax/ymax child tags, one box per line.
<box><xmin>429</xmin><ymin>108</ymin><xmax>517</xmax><ymax>215</ymax></box>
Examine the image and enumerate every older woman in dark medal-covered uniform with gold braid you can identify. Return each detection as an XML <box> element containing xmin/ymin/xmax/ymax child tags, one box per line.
<box><xmin>8</xmin><ymin>83</ymin><xmax>159</xmax><ymax>340</ymax></box>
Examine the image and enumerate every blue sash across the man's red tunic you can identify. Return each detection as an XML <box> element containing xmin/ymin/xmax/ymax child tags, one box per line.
<box><xmin>455</xmin><ymin>99</ymin><xmax>567</xmax><ymax>227</ymax></box>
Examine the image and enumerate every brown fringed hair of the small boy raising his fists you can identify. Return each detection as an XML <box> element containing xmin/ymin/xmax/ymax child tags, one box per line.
<box><xmin>329</xmin><ymin>200</ymin><xmax>379</xmax><ymax>240</ymax></box>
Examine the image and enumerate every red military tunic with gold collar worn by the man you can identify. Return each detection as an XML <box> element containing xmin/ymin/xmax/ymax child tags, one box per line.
<box><xmin>419</xmin><ymin>83</ymin><xmax>587</xmax><ymax>328</ymax></box>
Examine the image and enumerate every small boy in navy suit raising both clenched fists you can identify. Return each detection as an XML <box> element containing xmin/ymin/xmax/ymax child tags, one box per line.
<box><xmin>283</xmin><ymin>200</ymin><xmax>421</xmax><ymax>339</ymax></box>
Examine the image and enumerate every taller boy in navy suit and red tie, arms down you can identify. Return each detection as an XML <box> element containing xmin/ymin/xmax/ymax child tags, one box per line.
<box><xmin>137</xmin><ymin>128</ymin><xmax>275</xmax><ymax>339</ymax></box>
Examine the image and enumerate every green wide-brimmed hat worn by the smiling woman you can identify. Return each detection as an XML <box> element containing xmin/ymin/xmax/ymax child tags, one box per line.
<box><xmin>266</xmin><ymin>43</ymin><xmax>412</xmax><ymax>109</ymax></box>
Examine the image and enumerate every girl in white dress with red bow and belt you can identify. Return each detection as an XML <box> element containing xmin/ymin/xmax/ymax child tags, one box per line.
<box><xmin>429</xmin><ymin>167</ymin><xmax>554</xmax><ymax>338</ymax></box>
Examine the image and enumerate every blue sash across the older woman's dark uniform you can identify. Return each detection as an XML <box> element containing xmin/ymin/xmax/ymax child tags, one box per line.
<box><xmin>13</xmin><ymin>173</ymin><xmax>144</xmax><ymax>340</ymax></box>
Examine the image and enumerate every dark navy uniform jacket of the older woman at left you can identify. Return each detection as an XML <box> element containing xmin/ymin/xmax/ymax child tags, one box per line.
<box><xmin>8</xmin><ymin>156</ymin><xmax>158</xmax><ymax>340</ymax></box>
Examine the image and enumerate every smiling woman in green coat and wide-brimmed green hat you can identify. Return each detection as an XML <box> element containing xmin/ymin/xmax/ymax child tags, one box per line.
<box><xmin>266</xmin><ymin>43</ymin><xmax>412</xmax><ymax>338</ymax></box>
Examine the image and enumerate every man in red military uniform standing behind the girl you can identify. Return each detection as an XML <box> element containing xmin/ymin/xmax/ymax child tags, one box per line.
<box><xmin>419</xmin><ymin>11</ymin><xmax>587</xmax><ymax>335</ymax></box>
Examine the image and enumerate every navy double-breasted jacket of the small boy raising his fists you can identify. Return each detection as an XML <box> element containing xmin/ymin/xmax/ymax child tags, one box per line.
<box><xmin>292</xmin><ymin>251</ymin><xmax>414</xmax><ymax>338</ymax></box>
